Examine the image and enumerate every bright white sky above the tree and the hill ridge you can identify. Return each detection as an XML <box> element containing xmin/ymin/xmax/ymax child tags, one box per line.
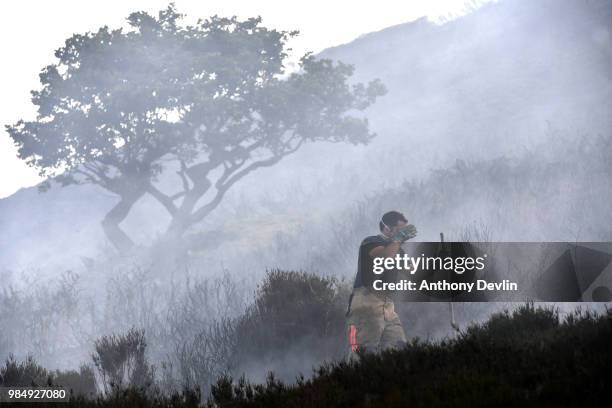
<box><xmin>0</xmin><ymin>0</ymin><xmax>486</xmax><ymax>198</ymax></box>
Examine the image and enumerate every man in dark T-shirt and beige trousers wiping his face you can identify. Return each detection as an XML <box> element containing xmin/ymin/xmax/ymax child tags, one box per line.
<box><xmin>347</xmin><ymin>211</ymin><xmax>416</xmax><ymax>360</ymax></box>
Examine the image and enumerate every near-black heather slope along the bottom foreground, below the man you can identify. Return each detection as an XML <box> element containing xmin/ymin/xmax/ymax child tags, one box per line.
<box><xmin>0</xmin><ymin>304</ymin><xmax>612</xmax><ymax>407</ymax></box>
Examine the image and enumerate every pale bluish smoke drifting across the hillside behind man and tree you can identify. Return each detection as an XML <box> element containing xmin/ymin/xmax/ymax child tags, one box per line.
<box><xmin>0</xmin><ymin>0</ymin><xmax>612</xmax><ymax>396</ymax></box>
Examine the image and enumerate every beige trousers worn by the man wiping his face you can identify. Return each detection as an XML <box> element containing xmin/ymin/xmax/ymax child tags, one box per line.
<box><xmin>347</xmin><ymin>288</ymin><xmax>406</xmax><ymax>359</ymax></box>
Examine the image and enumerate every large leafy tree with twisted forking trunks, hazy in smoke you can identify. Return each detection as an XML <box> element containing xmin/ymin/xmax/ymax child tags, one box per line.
<box><xmin>7</xmin><ymin>5</ymin><xmax>385</xmax><ymax>250</ymax></box>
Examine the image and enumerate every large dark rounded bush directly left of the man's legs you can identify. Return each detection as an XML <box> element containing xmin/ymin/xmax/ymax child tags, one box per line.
<box><xmin>235</xmin><ymin>270</ymin><xmax>349</xmax><ymax>379</ymax></box>
